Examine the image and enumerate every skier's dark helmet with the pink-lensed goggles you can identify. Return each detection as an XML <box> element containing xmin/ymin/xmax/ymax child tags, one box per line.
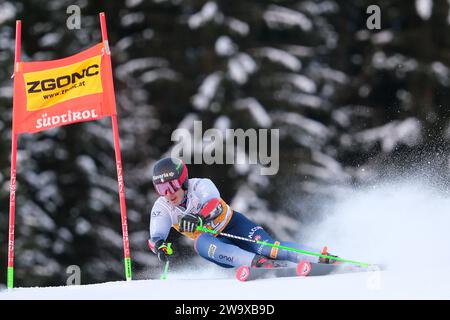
<box><xmin>153</xmin><ymin>157</ymin><xmax>188</xmax><ymax>196</ymax></box>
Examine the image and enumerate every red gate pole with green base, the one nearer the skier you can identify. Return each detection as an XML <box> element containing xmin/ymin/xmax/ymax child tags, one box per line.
<box><xmin>99</xmin><ymin>12</ymin><xmax>132</xmax><ymax>281</ymax></box>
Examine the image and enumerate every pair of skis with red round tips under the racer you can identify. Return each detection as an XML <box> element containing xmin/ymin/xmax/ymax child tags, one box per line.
<box><xmin>236</xmin><ymin>261</ymin><xmax>382</xmax><ymax>282</ymax></box>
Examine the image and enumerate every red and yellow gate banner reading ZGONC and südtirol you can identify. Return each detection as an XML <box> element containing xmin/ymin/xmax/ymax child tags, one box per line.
<box><xmin>13</xmin><ymin>43</ymin><xmax>116</xmax><ymax>134</ymax></box>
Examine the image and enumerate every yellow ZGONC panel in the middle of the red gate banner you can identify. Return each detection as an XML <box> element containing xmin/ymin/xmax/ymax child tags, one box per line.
<box><xmin>24</xmin><ymin>55</ymin><xmax>103</xmax><ymax>111</ymax></box>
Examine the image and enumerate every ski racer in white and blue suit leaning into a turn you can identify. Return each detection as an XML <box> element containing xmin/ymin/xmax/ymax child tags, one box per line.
<box><xmin>148</xmin><ymin>157</ymin><xmax>336</xmax><ymax>268</ymax></box>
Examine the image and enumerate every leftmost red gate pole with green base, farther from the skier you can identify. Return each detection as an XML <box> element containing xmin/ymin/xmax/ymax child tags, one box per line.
<box><xmin>7</xmin><ymin>20</ymin><xmax>22</xmax><ymax>289</ymax></box>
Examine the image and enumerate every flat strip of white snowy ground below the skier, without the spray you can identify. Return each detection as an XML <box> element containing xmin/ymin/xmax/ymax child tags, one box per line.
<box><xmin>0</xmin><ymin>268</ymin><xmax>450</xmax><ymax>300</ymax></box>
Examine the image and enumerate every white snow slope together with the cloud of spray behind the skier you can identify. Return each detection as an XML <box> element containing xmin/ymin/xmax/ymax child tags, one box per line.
<box><xmin>0</xmin><ymin>181</ymin><xmax>450</xmax><ymax>301</ymax></box>
